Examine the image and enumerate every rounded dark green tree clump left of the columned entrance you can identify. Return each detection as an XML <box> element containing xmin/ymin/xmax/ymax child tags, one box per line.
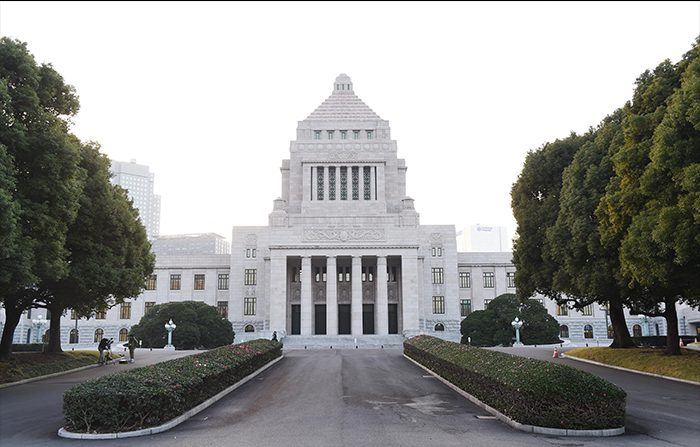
<box><xmin>131</xmin><ymin>301</ymin><xmax>235</xmax><ymax>349</ymax></box>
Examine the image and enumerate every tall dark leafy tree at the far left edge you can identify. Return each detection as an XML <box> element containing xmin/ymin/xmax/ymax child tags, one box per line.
<box><xmin>0</xmin><ymin>37</ymin><xmax>81</xmax><ymax>358</ymax></box>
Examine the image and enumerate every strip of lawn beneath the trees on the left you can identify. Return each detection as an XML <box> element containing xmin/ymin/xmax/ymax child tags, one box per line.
<box><xmin>0</xmin><ymin>351</ymin><xmax>100</xmax><ymax>384</ymax></box>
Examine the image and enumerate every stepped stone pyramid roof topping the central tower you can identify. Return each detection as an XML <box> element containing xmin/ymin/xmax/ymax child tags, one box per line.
<box><xmin>306</xmin><ymin>73</ymin><xmax>381</xmax><ymax>121</ymax></box>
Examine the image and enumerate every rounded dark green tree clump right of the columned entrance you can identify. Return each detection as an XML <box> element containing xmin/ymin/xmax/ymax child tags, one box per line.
<box><xmin>461</xmin><ymin>293</ymin><xmax>561</xmax><ymax>346</ymax></box>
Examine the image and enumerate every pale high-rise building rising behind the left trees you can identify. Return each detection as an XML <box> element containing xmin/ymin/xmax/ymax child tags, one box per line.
<box><xmin>110</xmin><ymin>159</ymin><xmax>160</xmax><ymax>240</ymax></box>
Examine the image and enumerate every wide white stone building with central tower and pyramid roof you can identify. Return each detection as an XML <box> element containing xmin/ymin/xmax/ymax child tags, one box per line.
<box><xmin>0</xmin><ymin>75</ymin><xmax>700</xmax><ymax>349</ymax></box>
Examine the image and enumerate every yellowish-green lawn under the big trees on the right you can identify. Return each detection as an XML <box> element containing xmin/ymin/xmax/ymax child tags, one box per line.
<box><xmin>566</xmin><ymin>348</ymin><xmax>700</xmax><ymax>382</ymax></box>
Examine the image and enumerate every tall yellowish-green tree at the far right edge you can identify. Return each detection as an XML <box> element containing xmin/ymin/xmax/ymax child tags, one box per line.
<box><xmin>620</xmin><ymin>43</ymin><xmax>700</xmax><ymax>354</ymax></box>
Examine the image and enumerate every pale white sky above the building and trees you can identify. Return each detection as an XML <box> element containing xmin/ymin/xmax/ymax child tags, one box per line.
<box><xmin>0</xmin><ymin>1</ymin><xmax>700</xmax><ymax>247</ymax></box>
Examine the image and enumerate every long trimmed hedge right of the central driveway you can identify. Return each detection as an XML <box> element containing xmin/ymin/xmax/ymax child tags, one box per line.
<box><xmin>404</xmin><ymin>335</ymin><xmax>626</xmax><ymax>430</ymax></box>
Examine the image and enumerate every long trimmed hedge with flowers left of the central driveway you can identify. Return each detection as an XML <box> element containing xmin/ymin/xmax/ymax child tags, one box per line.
<box><xmin>63</xmin><ymin>339</ymin><xmax>282</xmax><ymax>433</ymax></box>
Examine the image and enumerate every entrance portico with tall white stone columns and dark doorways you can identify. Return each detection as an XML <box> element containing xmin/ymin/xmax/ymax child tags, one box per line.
<box><xmin>269</xmin><ymin>247</ymin><xmax>418</xmax><ymax>336</ymax></box>
